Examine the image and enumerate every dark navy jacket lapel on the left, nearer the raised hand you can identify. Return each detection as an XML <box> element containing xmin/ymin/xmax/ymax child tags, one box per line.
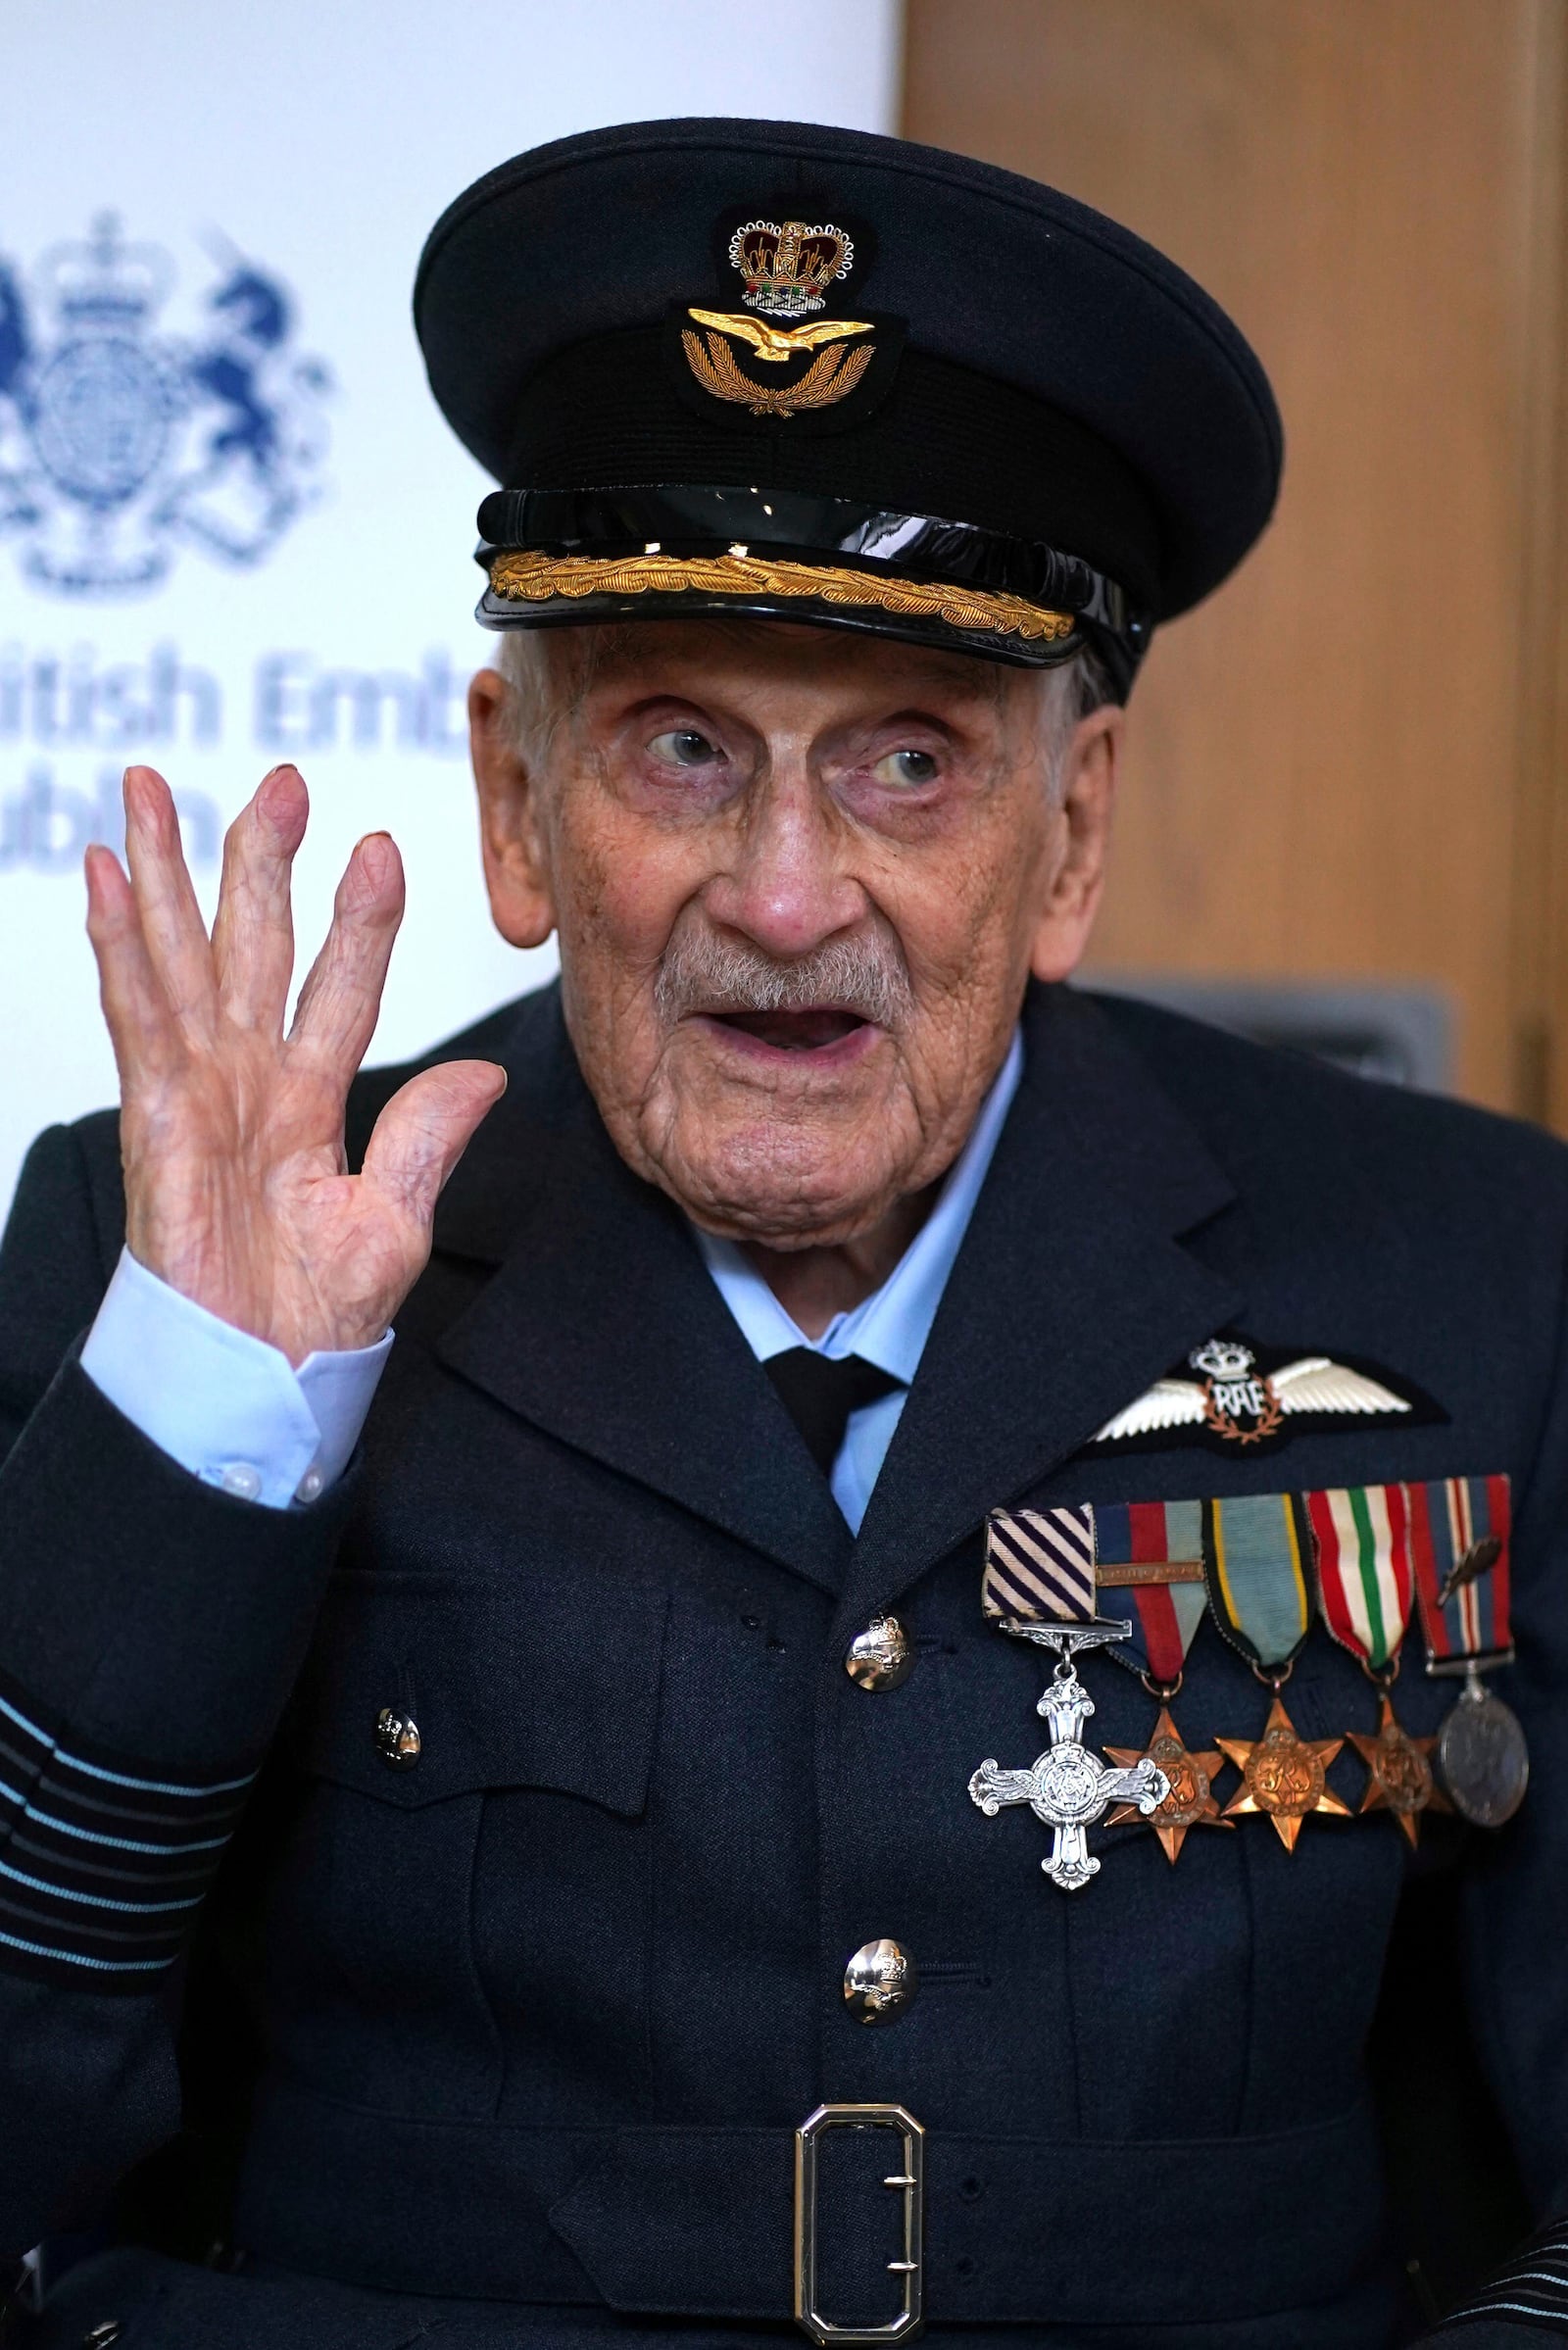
<box><xmin>435</xmin><ymin>992</ymin><xmax>851</xmax><ymax>1591</ymax></box>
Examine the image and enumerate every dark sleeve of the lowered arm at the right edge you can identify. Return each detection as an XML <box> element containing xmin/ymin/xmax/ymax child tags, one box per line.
<box><xmin>1432</xmin><ymin>1184</ymin><xmax>1568</xmax><ymax>2350</ymax></box>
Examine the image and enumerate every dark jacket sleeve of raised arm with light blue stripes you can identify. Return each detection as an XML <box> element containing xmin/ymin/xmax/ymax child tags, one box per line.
<box><xmin>0</xmin><ymin>1121</ymin><xmax>353</xmax><ymax>2261</ymax></box>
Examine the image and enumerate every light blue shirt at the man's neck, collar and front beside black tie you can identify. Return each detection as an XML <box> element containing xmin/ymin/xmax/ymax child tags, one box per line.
<box><xmin>696</xmin><ymin>1032</ymin><xmax>1022</xmax><ymax>1535</ymax></box>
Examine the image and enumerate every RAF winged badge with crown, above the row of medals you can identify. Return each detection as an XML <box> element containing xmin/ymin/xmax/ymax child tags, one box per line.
<box><xmin>1089</xmin><ymin>1337</ymin><xmax>1446</xmax><ymax>1452</ymax></box>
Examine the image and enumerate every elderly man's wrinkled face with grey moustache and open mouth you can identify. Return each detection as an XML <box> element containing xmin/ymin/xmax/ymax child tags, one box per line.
<box><xmin>472</xmin><ymin>620</ymin><xmax>1119</xmax><ymax>1248</ymax></box>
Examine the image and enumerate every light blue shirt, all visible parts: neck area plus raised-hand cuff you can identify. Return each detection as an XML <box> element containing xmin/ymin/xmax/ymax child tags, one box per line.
<box><xmin>82</xmin><ymin>1037</ymin><xmax>1022</xmax><ymax>1532</ymax></box>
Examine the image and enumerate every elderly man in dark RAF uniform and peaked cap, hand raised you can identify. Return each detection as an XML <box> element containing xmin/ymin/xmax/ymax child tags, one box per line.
<box><xmin>0</xmin><ymin>122</ymin><xmax>1568</xmax><ymax>2350</ymax></box>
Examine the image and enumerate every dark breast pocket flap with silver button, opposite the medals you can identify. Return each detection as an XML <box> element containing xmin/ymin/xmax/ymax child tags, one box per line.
<box><xmin>284</xmin><ymin>1567</ymin><xmax>670</xmax><ymax>1817</ymax></box>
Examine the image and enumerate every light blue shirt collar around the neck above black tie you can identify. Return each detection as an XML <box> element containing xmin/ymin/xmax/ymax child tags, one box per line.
<box><xmin>694</xmin><ymin>1032</ymin><xmax>1022</xmax><ymax>1387</ymax></box>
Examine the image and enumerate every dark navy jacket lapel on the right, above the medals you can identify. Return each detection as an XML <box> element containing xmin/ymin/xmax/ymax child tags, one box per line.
<box><xmin>844</xmin><ymin>990</ymin><xmax>1239</xmax><ymax>1619</ymax></box>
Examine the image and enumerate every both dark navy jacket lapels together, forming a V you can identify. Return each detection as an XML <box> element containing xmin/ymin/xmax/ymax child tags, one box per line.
<box><xmin>437</xmin><ymin>990</ymin><xmax>1239</xmax><ymax>1617</ymax></box>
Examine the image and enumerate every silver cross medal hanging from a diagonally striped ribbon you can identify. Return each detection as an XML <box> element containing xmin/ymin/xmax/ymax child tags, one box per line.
<box><xmin>968</xmin><ymin>1509</ymin><xmax>1171</xmax><ymax>1891</ymax></box>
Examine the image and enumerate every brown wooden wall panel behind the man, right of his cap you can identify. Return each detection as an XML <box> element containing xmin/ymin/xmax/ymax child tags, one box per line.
<box><xmin>903</xmin><ymin>0</ymin><xmax>1568</xmax><ymax>1126</ymax></box>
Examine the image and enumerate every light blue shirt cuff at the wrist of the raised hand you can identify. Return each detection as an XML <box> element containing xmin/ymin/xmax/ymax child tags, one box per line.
<box><xmin>82</xmin><ymin>1248</ymin><xmax>393</xmax><ymax>1509</ymax></box>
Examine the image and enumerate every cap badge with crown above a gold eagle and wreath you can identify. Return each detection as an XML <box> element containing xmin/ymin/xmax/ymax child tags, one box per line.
<box><xmin>670</xmin><ymin>217</ymin><xmax>903</xmax><ymax>427</ymax></box>
